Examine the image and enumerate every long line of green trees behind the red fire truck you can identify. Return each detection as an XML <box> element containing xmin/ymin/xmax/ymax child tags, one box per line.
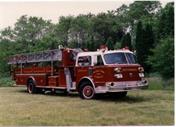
<box><xmin>0</xmin><ymin>1</ymin><xmax>174</xmax><ymax>79</ymax></box>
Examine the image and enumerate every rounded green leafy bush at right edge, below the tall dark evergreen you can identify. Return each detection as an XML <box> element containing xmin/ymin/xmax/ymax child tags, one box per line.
<box><xmin>148</xmin><ymin>37</ymin><xmax>174</xmax><ymax>79</ymax></box>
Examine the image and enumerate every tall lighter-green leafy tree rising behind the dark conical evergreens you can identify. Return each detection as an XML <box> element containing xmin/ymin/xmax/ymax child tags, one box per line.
<box><xmin>123</xmin><ymin>1</ymin><xmax>161</xmax><ymax>48</ymax></box>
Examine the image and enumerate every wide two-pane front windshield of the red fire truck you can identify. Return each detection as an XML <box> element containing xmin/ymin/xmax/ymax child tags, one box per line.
<box><xmin>104</xmin><ymin>52</ymin><xmax>136</xmax><ymax>64</ymax></box>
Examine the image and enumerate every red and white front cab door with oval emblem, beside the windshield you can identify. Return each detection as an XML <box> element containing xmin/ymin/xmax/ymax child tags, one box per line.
<box><xmin>92</xmin><ymin>55</ymin><xmax>107</xmax><ymax>86</ymax></box>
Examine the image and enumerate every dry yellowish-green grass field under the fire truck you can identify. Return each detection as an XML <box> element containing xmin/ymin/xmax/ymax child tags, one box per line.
<box><xmin>0</xmin><ymin>87</ymin><xmax>174</xmax><ymax>126</ymax></box>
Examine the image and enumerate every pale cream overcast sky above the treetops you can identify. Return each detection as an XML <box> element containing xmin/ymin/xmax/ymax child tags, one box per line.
<box><xmin>0</xmin><ymin>0</ymin><xmax>171</xmax><ymax>30</ymax></box>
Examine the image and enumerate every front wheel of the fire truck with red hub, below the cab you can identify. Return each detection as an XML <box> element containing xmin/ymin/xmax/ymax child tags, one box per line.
<box><xmin>79</xmin><ymin>82</ymin><xmax>95</xmax><ymax>100</ymax></box>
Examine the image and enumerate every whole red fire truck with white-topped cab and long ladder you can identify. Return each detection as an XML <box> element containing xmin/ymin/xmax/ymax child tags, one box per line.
<box><xmin>8</xmin><ymin>48</ymin><xmax>148</xmax><ymax>99</ymax></box>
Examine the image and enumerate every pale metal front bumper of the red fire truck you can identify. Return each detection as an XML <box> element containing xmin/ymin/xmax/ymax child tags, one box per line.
<box><xmin>95</xmin><ymin>80</ymin><xmax>148</xmax><ymax>93</ymax></box>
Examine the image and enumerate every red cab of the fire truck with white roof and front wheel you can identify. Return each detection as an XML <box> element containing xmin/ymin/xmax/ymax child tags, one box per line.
<box><xmin>75</xmin><ymin>49</ymin><xmax>148</xmax><ymax>99</ymax></box>
